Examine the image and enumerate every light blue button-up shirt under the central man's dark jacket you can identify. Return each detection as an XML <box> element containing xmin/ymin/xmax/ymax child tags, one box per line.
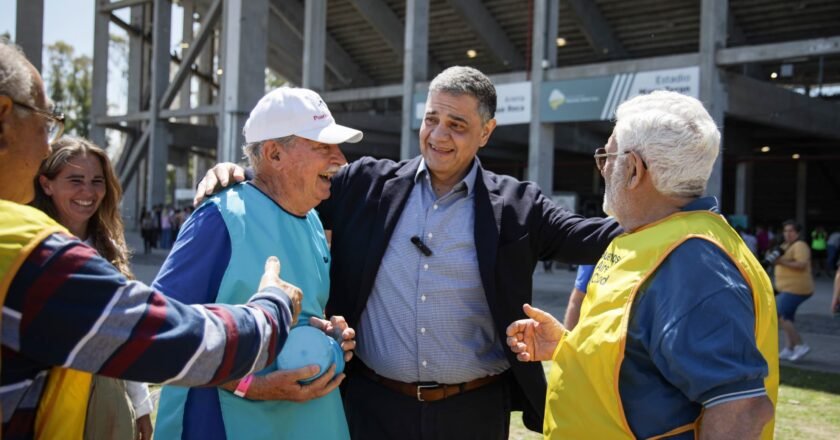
<box><xmin>356</xmin><ymin>159</ymin><xmax>510</xmax><ymax>384</ymax></box>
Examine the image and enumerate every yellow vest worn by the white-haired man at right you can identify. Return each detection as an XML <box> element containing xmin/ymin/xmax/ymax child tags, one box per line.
<box><xmin>543</xmin><ymin>211</ymin><xmax>779</xmax><ymax>439</ymax></box>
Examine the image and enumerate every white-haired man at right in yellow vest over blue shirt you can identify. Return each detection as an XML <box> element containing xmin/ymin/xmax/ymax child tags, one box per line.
<box><xmin>507</xmin><ymin>91</ymin><xmax>779</xmax><ymax>439</ymax></box>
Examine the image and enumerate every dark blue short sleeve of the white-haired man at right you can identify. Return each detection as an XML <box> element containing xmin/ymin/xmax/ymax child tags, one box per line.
<box><xmin>631</xmin><ymin>239</ymin><xmax>768</xmax><ymax>407</ymax></box>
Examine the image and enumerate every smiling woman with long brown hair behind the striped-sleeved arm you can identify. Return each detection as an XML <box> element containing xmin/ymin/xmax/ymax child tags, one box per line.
<box><xmin>32</xmin><ymin>136</ymin><xmax>152</xmax><ymax>440</ymax></box>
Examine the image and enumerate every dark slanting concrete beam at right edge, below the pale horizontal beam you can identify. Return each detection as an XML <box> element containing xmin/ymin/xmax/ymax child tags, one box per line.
<box><xmin>726</xmin><ymin>73</ymin><xmax>840</xmax><ymax>140</ymax></box>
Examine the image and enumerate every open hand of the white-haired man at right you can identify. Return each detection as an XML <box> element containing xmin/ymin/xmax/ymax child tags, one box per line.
<box><xmin>507</xmin><ymin>304</ymin><xmax>566</xmax><ymax>362</ymax></box>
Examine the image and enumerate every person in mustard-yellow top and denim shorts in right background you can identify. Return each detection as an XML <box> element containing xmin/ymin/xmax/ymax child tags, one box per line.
<box><xmin>774</xmin><ymin>220</ymin><xmax>814</xmax><ymax>362</ymax></box>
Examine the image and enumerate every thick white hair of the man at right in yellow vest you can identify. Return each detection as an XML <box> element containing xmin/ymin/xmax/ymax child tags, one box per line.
<box><xmin>613</xmin><ymin>91</ymin><xmax>720</xmax><ymax>197</ymax></box>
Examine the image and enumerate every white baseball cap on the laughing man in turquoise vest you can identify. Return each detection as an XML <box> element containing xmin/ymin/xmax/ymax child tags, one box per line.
<box><xmin>242</xmin><ymin>87</ymin><xmax>362</xmax><ymax>144</ymax></box>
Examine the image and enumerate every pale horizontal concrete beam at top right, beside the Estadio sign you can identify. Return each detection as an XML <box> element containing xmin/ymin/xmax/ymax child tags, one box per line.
<box><xmin>715</xmin><ymin>36</ymin><xmax>840</xmax><ymax>66</ymax></box>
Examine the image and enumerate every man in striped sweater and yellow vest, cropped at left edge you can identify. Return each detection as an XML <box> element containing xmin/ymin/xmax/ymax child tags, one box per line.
<box><xmin>0</xmin><ymin>39</ymin><xmax>301</xmax><ymax>440</ymax></box>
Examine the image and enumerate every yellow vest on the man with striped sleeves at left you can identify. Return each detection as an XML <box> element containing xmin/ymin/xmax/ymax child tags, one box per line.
<box><xmin>0</xmin><ymin>200</ymin><xmax>91</xmax><ymax>439</ymax></box>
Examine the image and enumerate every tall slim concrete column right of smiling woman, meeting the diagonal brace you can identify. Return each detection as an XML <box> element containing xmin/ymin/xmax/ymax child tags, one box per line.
<box><xmin>146</xmin><ymin>0</ymin><xmax>172</xmax><ymax>209</ymax></box>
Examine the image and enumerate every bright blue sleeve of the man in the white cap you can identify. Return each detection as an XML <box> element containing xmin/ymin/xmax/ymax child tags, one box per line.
<box><xmin>152</xmin><ymin>203</ymin><xmax>231</xmax><ymax>304</ymax></box>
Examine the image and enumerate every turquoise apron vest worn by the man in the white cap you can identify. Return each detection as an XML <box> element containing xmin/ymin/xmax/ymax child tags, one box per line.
<box><xmin>155</xmin><ymin>183</ymin><xmax>350</xmax><ymax>439</ymax></box>
